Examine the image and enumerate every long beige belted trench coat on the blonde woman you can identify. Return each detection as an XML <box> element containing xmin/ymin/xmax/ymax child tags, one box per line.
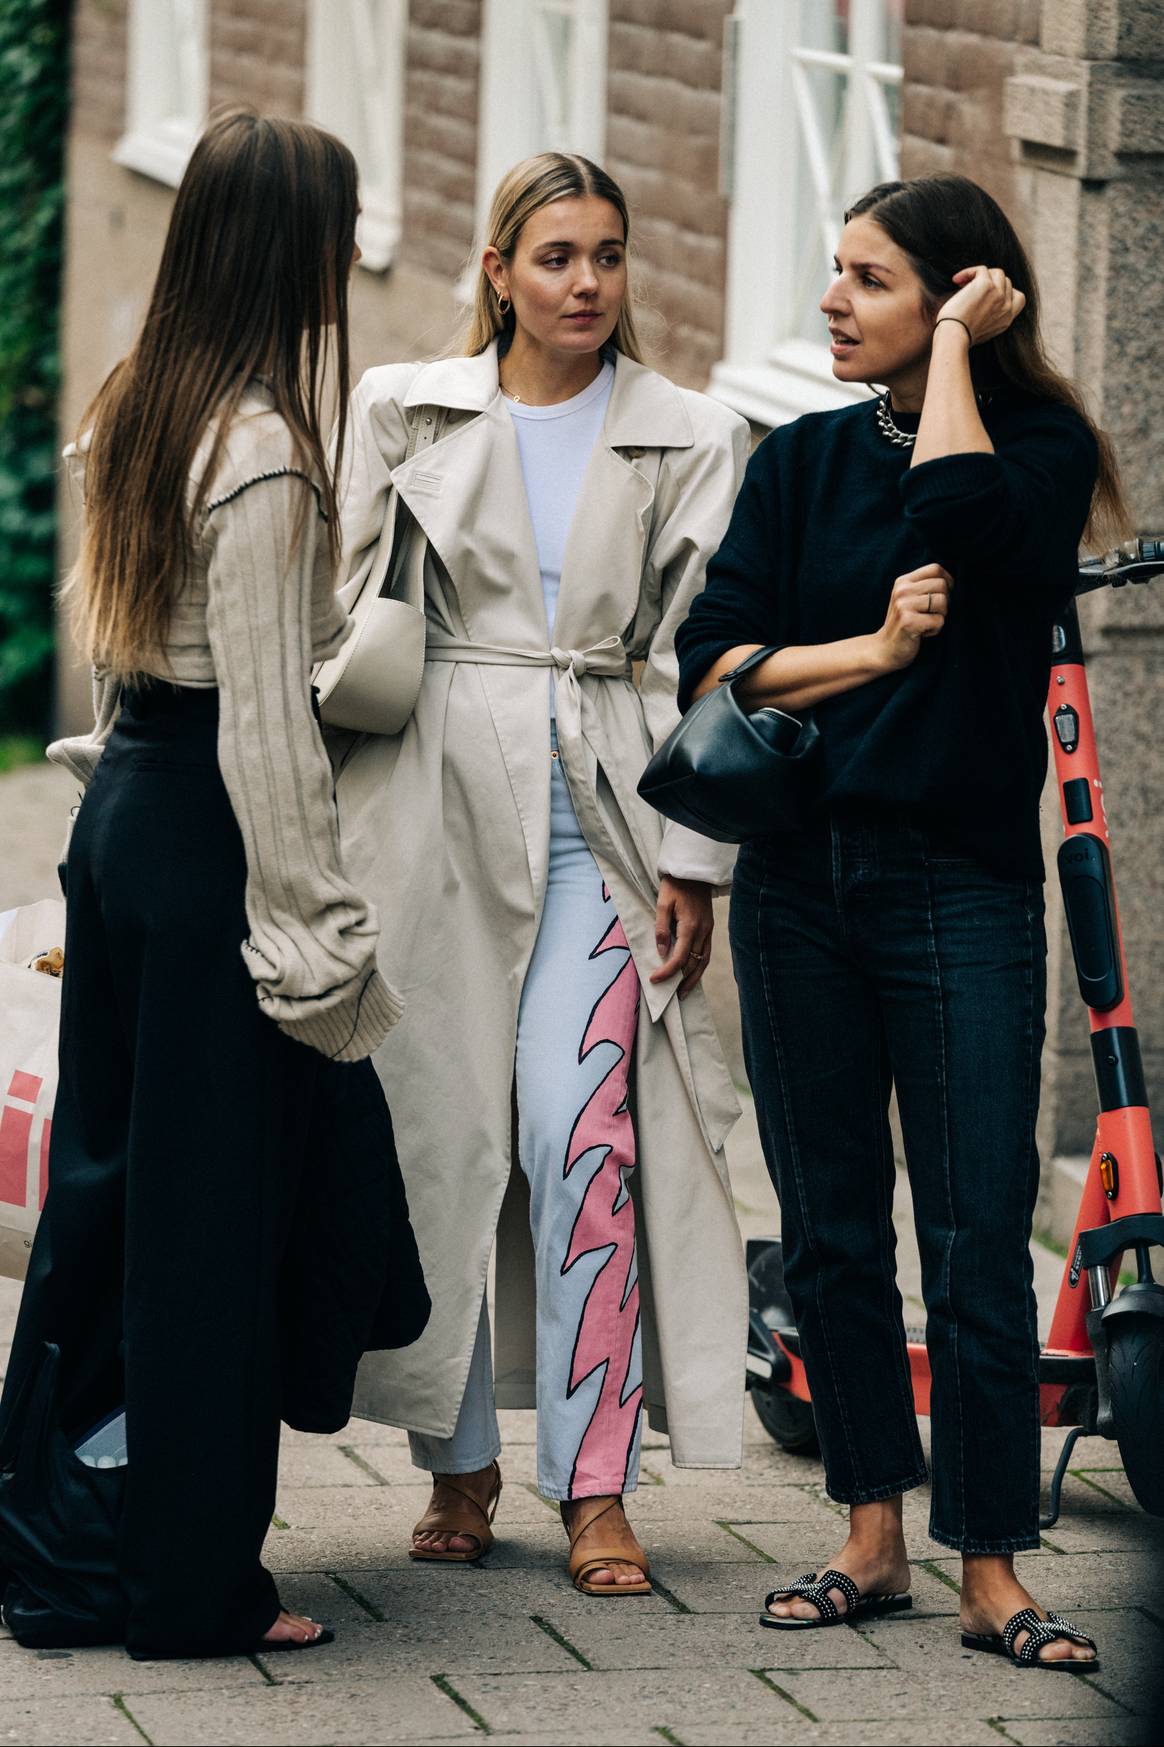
<box><xmin>334</xmin><ymin>337</ymin><xmax>748</xmax><ymax>1467</ymax></box>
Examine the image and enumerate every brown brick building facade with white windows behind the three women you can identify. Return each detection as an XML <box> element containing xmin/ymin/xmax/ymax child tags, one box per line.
<box><xmin>59</xmin><ymin>0</ymin><xmax>1164</xmax><ymax>1229</ymax></box>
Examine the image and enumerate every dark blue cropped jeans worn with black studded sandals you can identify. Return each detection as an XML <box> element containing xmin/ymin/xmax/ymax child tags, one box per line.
<box><xmin>731</xmin><ymin>821</ymin><xmax>1047</xmax><ymax>1553</ymax></box>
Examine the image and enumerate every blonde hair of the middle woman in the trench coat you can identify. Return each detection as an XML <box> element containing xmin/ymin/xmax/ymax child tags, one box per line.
<box><xmin>461</xmin><ymin>152</ymin><xmax>643</xmax><ymax>363</ymax></box>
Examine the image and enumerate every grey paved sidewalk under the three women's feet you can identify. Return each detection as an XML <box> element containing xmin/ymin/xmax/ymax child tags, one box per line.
<box><xmin>0</xmin><ymin>770</ymin><xmax>1164</xmax><ymax>1747</ymax></box>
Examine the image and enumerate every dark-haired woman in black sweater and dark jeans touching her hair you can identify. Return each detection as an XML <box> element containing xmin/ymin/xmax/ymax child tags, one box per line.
<box><xmin>678</xmin><ymin>176</ymin><xmax>1120</xmax><ymax>1668</ymax></box>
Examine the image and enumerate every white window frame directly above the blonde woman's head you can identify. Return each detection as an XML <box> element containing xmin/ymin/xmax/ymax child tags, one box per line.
<box><xmin>467</xmin><ymin>0</ymin><xmax>608</xmax><ymax>253</ymax></box>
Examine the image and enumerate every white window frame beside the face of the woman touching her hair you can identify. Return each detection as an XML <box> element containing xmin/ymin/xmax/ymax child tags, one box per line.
<box><xmin>710</xmin><ymin>0</ymin><xmax>902</xmax><ymax>426</ymax></box>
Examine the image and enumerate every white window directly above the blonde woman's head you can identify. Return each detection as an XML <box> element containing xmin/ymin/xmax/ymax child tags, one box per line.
<box><xmin>477</xmin><ymin>0</ymin><xmax>606</xmax><ymax>242</ymax></box>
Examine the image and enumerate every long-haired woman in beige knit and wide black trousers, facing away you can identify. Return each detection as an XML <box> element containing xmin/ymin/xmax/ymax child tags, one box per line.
<box><xmin>0</xmin><ymin>112</ymin><xmax>428</xmax><ymax>1656</ymax></box>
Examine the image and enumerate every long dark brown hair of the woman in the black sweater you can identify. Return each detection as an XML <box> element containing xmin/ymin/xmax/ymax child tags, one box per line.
<box><xmin>844</xmin><ymin>175</ymin><xmax>1131</xmax><ymax>549</ymax></box>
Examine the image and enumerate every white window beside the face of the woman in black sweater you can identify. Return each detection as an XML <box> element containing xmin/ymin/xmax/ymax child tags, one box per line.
<box><xmin>711</xmin><ymin>0</ymin><xmax>905</xmax><ymax>425</ymax></box>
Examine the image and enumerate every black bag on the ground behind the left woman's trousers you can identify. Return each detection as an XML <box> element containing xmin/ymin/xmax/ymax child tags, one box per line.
<box><xmin>0</xmin><ymin>1342</ymin><xmax>128</xmax><ymax>1649</ymax></box>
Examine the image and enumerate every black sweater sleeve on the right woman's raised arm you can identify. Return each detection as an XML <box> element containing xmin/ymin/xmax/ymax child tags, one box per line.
<box><xmin>900</xmin><ymin>407</ymin><xmax>1098</xmax><ymax>582</ymax></box>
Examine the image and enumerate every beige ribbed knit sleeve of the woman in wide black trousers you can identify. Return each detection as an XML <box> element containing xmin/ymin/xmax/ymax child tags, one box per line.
<box><xmin>206</xmin><ymin>472</ymin><xmax>402</xmax><ymax>1062</ymax></box>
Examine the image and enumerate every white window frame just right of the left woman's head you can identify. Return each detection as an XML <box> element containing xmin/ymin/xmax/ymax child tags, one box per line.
<box><xmin>306</xmin><ymin>0</ymin><xmax>409</xmax><ymax>273</ymax></box>
